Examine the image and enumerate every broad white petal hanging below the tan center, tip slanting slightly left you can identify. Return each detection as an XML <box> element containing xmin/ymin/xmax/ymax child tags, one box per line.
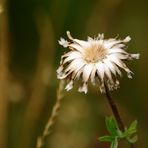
<box><xmin>83</xmin><ymin>63</ymin><xmax>94</xmax><ymax>82</ymax></box>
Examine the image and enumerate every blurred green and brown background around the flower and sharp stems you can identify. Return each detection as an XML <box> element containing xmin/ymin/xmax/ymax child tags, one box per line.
<box><xmin>0</xmin><ymin>0</ymin><xmax>148</xmax><ymax>148</ymax></box>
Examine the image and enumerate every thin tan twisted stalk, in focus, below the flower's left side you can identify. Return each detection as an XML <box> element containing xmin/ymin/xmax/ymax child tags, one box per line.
<box><xmin>36</xmin><ymin>81</ymin><xmax>64</xmax><ymax>148</ymax></box>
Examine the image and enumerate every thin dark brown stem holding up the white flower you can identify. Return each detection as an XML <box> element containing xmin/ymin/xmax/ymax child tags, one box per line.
<box><xmin>105</xmin><ymin>84</ymin><xmax>135</xmax><ymax>148</ymax></box>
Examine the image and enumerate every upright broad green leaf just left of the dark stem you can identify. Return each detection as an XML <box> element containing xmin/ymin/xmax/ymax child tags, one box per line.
<box><xmin>105</xmin><ymin>117</ymin><xmax>119</xmax><ymax>136</ymax></box>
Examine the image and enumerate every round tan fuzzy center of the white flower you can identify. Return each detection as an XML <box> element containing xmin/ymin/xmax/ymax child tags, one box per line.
<box><xmin>84</xmin><ymin>43</ymin><xmax>106</xmax><ymax>63</ymax></box>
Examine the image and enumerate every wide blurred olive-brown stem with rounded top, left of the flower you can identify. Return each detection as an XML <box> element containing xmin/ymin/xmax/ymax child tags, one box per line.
<box><xmin>19</xmin><ymin>9</ymin><xmax>54</xmax><ymax>148</ymax></box>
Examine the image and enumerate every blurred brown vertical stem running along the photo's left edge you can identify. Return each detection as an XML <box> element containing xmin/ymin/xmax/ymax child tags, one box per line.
<box><xmin>0</xmin><ymin>0</ymin><xmax>9</xmax><ymax>148</ymax></box>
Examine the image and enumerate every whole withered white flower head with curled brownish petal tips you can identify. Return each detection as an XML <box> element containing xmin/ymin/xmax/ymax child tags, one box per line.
<box><xmin>57</xmin><ymin>31</ymin><xmax>139</xmax><ymax>93</ymax></box>
